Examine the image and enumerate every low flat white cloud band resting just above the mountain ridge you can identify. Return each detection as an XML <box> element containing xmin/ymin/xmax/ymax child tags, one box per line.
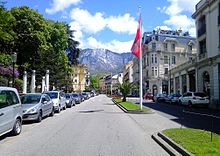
<box><xmin>87</xmin><ymin>37</ymin><xmax>133</xmax><ymax>53</ymax></box>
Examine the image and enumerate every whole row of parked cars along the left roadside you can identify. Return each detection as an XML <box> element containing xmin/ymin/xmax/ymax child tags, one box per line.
<box><xmin>0</xmin><ymin>87</ymin><xmax>98</xmax><ymax>136</ymax></box>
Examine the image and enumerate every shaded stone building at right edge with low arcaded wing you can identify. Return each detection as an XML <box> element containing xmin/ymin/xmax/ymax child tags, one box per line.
<box><xmin>171</xmin><ymin>0</ymin><xmax>220</xmax><ymax>109</ymax></box>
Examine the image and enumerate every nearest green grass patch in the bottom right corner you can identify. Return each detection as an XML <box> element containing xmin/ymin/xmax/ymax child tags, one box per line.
<box><xmin>163</xmin><ymin>128</ymin><xmax>220</xmax><ymax>156</ymax></box>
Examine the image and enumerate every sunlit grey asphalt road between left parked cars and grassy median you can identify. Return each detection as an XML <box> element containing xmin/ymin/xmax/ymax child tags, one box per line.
<box><xmin>0</xmin><ymin>95</ymin><xmax>168</xmax><ymax>156</ymax></box>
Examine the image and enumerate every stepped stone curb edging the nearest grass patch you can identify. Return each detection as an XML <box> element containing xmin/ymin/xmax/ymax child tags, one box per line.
<box><xmin>151</xmin><ymin>132</ymin><xmax>194</xmax><ymax>156</ymax></box>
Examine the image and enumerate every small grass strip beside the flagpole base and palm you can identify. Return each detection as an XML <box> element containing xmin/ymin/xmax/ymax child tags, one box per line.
<box><xmin>114</xmin><ymin>99</ymin><xmax>150</xmax><ymax>111</ymax></box>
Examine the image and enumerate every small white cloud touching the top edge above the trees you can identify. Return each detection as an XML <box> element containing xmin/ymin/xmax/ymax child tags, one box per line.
<box><xmin>46</xmin><ymin>0</ymin><xmax>81</xmax><ymax>14</ymax></box>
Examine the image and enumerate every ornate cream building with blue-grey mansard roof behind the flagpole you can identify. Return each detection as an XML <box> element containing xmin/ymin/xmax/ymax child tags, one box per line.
<box><xmin>143</xmin><ymin>30</ymin><xmax>196</xmax><ymax>95</ymax></box>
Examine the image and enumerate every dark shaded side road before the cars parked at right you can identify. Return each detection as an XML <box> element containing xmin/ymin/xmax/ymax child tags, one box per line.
<box><xmin>143</xmin><ymin>102</ymin><xmax>220</xmax><ymax>134</ymax></box>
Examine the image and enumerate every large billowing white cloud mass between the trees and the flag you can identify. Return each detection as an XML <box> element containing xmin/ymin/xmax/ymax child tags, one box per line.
<box><xmin>70</xmin><ymin>8</ymin><xmax>138</xmax><ymax>52</ymax></box>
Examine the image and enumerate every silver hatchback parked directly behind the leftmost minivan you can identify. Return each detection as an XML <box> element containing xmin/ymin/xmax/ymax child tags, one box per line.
<box><xmin>21</xmin><ymin>93</ymin><xmax>54</xmax><ymax>122</ymax></box>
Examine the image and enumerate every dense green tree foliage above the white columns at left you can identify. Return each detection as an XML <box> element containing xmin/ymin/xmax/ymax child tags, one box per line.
<box><xmin>0</xmin><ymin>2</ymin><xmax>79</xmax><ymax>88</ymax></box>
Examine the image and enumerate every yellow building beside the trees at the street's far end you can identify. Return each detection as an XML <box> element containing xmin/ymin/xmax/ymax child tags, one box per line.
<box><xmin>71</xmin><ymin>64</ymin><xmax>88</xmax><ymax>92</ymax></box>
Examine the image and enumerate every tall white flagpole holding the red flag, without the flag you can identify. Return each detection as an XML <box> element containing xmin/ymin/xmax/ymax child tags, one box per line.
<box><xmin>139</xmin><ymin>7</ymin><xmax>143</xmax><ymax>110</ymax></box>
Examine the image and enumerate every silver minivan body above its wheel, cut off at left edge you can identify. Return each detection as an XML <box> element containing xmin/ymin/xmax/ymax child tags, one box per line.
<box><xmin>0</xmin><ymin>90</ymin><xmax>21</xmax><ymax>134</ymax></box>
